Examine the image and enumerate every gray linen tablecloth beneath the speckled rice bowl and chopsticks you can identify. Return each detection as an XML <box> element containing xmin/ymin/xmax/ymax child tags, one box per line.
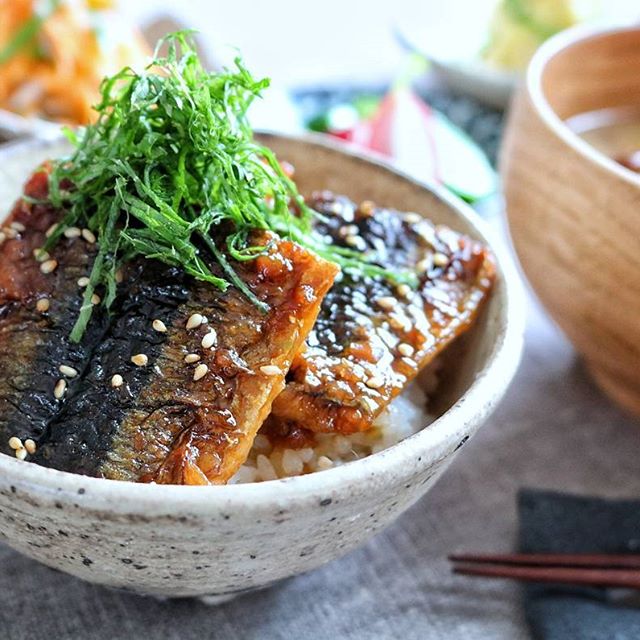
<box><xmin>0</xmin><ymin>272</ymin><xmax>640</xmax><ymax>640</ymax></box>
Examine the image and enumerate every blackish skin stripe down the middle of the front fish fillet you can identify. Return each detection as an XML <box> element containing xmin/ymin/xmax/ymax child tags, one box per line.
<box><xmin>32</xmin><ymin>263</ymin><xmax>190</xmax><ymax>480</ymax></box>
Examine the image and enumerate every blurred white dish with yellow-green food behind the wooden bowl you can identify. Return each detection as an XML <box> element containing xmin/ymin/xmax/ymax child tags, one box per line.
<box><xmin>397</xmin><ymin>0</ymin><xmax>638</xmax><ymax>109</ymax></box>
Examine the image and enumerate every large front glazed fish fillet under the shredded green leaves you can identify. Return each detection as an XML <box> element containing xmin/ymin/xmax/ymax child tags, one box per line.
<box><xmin>0</xmin><ymin>170</ymin><xmax>337</xmax><ymax>484</ymax></box>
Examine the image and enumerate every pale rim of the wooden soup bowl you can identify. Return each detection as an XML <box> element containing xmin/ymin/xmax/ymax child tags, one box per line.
<box><xmin>525</xmin><ymin>23</ymin><xmax>640</xmax><ymax>187</ymax></box>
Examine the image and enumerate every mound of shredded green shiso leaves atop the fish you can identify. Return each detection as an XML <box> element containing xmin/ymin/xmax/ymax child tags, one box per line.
<box><xmin>44</xmin><ymin>32</ymin><xmax>415</xmax><ymax>342</ymax></box>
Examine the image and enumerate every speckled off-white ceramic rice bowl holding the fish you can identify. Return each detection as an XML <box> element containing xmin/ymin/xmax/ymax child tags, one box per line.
<box><xmin>0</xmin><ymin>135</ymin><xmax>523</xmax><ymax>600</ymax></box>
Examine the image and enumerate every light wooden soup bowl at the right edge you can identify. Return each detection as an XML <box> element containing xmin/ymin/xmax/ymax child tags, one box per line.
<box><xmin>500</xmin><ymin>27</ymin><xmax>640</xmax><ymax>414</ymax></box>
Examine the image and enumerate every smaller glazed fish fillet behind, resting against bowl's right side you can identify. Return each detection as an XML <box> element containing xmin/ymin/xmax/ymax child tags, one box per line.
<box><xmin>266</xmin><ymin>192</ymin><xmax>495</xmax><ymax>435</ymax></box>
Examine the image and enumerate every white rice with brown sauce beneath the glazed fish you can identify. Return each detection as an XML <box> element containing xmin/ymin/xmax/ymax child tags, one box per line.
<box><xmin>229</xmin><ymin>363</ymin><xmax>437</xmax><ymax>484</ymax></box>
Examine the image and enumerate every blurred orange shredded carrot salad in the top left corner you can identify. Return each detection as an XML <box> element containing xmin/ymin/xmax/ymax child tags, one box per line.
<box><xmin>0</xmin><ymin>0</ymin><xmax>149</xmax><ymax>125</ymax></box>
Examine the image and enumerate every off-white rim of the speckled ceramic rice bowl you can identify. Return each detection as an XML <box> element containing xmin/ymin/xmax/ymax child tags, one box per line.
<box><xmin>0</xmin><ymin>131</ymin><xmax>526</xmax><ymax>514</ymax></box>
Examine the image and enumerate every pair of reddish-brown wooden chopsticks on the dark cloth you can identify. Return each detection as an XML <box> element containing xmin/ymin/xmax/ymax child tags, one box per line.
<box><xmin>450</xmin><ymin>554</ymin><xmax>640</xmax><ymax>589</ymax></box>
